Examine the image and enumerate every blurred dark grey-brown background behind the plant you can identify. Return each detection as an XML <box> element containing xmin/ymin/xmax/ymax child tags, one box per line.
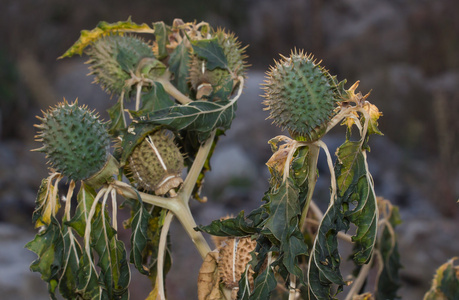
<box><xmin>0</xmin><ymin>0</ymin><xmax>459</xmax><ymax>299</ymax></box>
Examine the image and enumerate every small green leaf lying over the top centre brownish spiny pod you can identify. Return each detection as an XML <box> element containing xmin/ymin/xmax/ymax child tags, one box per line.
<box><xmin>191</xmin><ymin>37</ymin><xmax>228</xmax><ymax>70</ymax></box>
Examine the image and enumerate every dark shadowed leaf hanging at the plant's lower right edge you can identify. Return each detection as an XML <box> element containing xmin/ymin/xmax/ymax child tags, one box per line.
<box><xmin>375</xmin><ymin>199</ymin><xmax>402</xmax><ymax>300</ymax></box>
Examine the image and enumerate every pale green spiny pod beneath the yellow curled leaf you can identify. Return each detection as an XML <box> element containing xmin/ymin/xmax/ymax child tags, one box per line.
<box><xmin>86</xmin><ymin>35</ymin><xmax>154</xmax><ymax>95</ymax></box>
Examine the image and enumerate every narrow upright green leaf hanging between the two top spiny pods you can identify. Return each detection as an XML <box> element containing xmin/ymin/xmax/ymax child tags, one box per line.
<box><xmin>169</xmin><ymin>43</ymin><xmax>190</xmax><ymax>95</ymax></box>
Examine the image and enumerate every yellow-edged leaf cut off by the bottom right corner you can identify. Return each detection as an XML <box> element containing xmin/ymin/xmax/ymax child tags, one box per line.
<box><xmin>424</xmin><ymin>257</ymin><xmax>459</xmax><ymax>300</ymax></box>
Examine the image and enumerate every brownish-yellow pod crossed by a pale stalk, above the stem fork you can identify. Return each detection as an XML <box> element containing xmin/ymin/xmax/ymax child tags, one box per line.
<box><xmin>128</xmin><ymin>130</ymin><xmax>183</xmax><ymax>195</ymax></box>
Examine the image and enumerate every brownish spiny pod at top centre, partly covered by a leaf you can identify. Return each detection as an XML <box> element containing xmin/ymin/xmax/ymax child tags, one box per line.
<box><xmin>189</xmin><ymin>29</ymin><xmax>247</xmax><ymax>99</ymax></box>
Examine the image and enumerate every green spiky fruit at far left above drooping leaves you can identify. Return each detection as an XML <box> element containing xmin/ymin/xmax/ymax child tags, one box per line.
<box><xmin>35</xmin><ymin>99</ymin><xmax>110</xmax><ymax>180</ymax></box>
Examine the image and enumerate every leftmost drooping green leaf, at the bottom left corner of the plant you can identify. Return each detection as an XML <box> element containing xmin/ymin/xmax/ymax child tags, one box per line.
<box><xmin>25</xmin><ymin>217</ymin><xmax>63</xmax><ymax>299</ymax></box>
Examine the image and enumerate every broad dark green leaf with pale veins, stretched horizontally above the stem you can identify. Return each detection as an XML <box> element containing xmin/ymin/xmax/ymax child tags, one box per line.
<box><xmin>130</xmin><ymin>99</ymin><xmax>236</xmax><ymax>143</ymax></box>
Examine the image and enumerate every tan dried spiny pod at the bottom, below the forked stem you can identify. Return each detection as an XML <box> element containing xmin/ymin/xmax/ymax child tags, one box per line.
<box><xmin>218</xmin><ymin>237</ymin><xmax>257</xmax><ymax>288</ymax></box>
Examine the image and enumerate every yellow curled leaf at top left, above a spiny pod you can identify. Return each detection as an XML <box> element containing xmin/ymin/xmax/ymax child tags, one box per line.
<box><xmin>59</xmin><ymin>18</ymin><xmax>153</xmax><ymax>58</ymax></box>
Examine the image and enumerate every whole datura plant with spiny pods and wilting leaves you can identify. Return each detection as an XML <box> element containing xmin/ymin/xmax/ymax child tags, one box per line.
<box><xmin>26</xmin><ymin>19</ymin><xmax>414</xmax><ymax>300</ymax></box>
